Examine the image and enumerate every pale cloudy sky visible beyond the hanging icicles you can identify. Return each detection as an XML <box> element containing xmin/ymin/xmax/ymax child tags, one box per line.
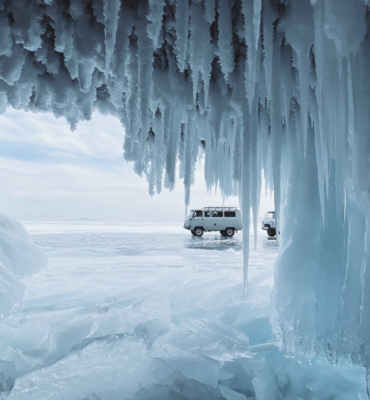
<box><xmin>0</xmin><ymin>109</ymin><xmax>274</xmax><ymax>223</ymax></box>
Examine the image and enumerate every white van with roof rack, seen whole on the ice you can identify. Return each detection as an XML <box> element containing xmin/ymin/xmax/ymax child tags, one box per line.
<box><xmin>184</xmin><ymin>207</ymin><xmax>242</xmax><ymax>237</ymax></box>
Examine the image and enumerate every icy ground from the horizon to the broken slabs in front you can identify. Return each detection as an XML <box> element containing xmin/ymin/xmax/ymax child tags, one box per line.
<box><xmin>0</xmin><ymin>223</ymin><xmax>366</xmax><ymax>400</ymax></box>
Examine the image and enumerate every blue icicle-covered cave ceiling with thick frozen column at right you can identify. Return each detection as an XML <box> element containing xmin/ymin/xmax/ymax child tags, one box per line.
<box><xmin>0</xmin><ymin>0</ymin><xmax>370</xmax><ymax>394</ymax></box>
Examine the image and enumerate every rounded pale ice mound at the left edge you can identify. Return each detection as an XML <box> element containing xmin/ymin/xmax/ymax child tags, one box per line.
<box><xmin>0</xmin><ymin>214</ymin><xmax>47</xmax><ymax>319</ymax></box>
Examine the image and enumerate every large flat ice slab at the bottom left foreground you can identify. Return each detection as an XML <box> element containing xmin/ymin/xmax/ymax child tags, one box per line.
<box><xmin>8</xmin><ymin>337</ymin><xmax>173</xmax><ymax>400</ymax></box>
